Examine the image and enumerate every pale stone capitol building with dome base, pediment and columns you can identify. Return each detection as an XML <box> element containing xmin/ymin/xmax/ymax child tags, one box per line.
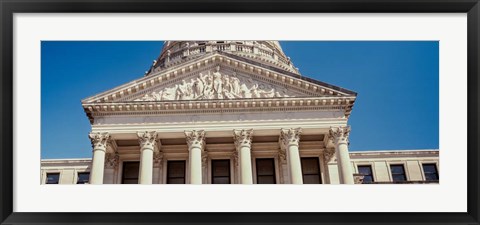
<box><xmin>41</xmin><ymin>41</ymin><xmax>439</xmax><ymax>184</ymax></box>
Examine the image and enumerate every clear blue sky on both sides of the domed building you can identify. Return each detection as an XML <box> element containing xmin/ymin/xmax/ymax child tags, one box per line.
<box><xmin>41</xmin><ymin>41</ymin><xmax>439</xmax><ymax>159</ymax></box>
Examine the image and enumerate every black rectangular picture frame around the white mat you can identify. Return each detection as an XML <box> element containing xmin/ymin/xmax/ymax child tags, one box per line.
<box><xmin>0</xmin><ymin>0</ymin><xmax>480</xmax><ymax>225</ymax></box>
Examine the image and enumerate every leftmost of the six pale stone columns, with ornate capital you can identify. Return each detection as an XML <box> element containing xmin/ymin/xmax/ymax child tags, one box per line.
<box><xmin>88</xmin><ymin>132</ymin><xmax>110</xmax><ymax>184</ymax></box>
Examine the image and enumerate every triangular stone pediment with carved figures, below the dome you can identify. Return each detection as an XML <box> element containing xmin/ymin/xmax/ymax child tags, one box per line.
<box><xmin>82</xmin><ymin>54</ymin><xmax>356</xmax><ymax>104</ymax></box>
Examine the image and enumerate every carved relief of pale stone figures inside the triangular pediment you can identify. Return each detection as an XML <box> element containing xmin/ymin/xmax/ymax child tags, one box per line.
<box><xmin>135</xmin><ymin>66</ymin><xmax>290</xmax><ymax>101</ymax></box>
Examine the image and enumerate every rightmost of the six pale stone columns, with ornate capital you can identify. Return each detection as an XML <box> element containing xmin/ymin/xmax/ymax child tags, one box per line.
<box><xmin>330</xmin><ymin>127</ymin><xmax>354</xmax><ymax>184</ymax></box>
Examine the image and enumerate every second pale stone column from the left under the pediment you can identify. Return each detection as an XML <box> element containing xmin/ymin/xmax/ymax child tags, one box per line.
<box><xmin>137</xmin><ymin>131</ymin><xmax>157</xmax><ymax>184</ymax></box>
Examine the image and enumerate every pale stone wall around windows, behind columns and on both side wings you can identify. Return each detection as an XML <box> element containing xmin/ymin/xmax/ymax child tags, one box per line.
<box><xmin>41</xmin><ymin>150</ymin><xmax>440</xmax><ymax>184</ymax></box>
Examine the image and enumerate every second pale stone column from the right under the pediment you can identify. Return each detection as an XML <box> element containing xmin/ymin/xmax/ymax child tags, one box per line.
<box><xmin>280</xmin><ymin>128</ymin><xmax>303</xmax><ymax>184</ymax></box>
